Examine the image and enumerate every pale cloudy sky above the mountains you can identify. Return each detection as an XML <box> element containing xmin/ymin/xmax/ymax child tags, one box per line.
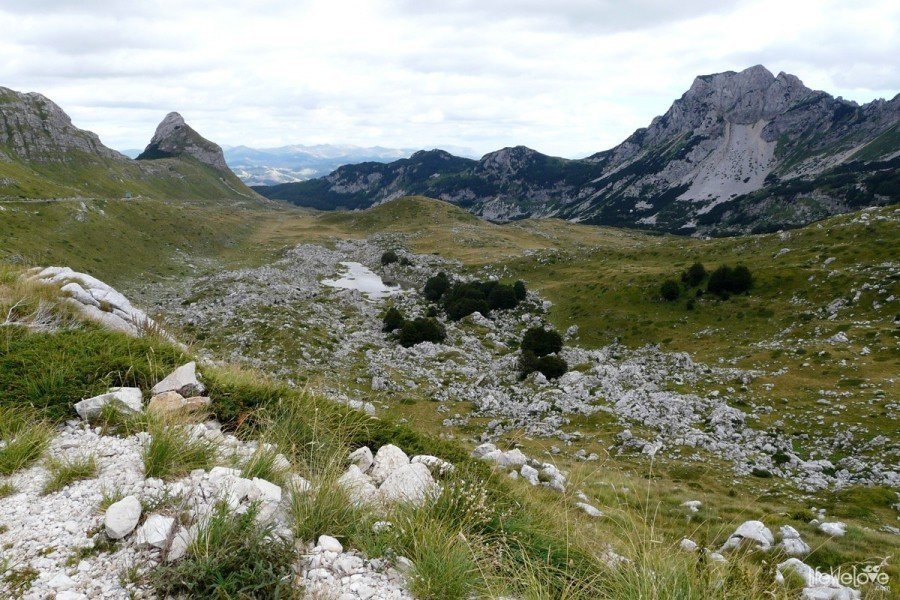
<box><xmin>0</xmin><ymin>0</ymin><xmax>900</xmax><ymax>158</ymax></box>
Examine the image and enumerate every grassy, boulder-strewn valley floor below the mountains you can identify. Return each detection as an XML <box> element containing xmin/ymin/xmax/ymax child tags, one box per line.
<box><xmin>0</xmin><ymin>197</ymin><xmax>900</xmax><ymax>599</ymax></box>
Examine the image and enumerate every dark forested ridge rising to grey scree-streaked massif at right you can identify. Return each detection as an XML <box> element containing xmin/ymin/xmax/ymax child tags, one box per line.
<box><xmin>255</xmin><ymin>65</ymin><xmax>900</xmax><ymax>234</ymax></box>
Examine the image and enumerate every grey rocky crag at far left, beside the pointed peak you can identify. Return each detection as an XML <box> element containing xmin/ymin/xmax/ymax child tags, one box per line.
<box><xmin>0</xmin><ymin>87</ymin><xmax>123</xmax><ymax>162</ymax></box>
